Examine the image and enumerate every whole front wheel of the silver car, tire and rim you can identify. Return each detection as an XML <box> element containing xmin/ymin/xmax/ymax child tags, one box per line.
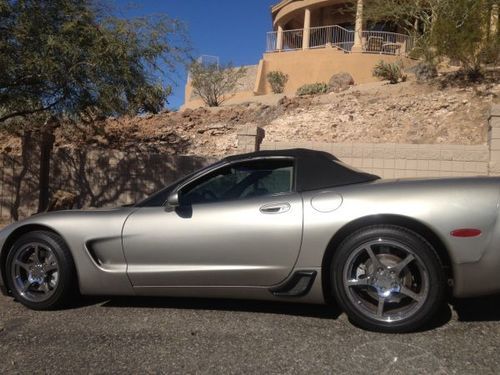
<box><xmin>6</xmin><ymin>231</ymin><xmax>78</xmax><ymax>310</ymax></box>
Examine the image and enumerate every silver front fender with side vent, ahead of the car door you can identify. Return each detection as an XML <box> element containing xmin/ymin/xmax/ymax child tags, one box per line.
<box><xmin>0</xmin><ymin>208</ymin><xmax>135</xmax><ymax>295</ymax></box>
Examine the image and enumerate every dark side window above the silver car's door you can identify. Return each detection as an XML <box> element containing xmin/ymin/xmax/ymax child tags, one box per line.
<box><xmin>179</xmin><ymin>159</ymin><xmax>293</xmax><ymax>205</ymax></box>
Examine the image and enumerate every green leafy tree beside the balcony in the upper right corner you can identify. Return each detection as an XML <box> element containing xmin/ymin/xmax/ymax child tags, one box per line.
<box><xmin>352</xmin><ymin>0</ymin><xmax>499</xmax><ymax>75</ymax></box>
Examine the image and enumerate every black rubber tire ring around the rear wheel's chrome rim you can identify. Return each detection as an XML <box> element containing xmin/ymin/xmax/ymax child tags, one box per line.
<box><xmin>330</xmin><ymin>226</ymin><xmax>445</xmax><ymax>333</ymax></box>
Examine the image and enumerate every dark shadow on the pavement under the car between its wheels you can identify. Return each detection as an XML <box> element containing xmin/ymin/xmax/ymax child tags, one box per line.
<box><xmin>98</xmin><ymin>297</ymin><xmax>341</xmax><ymax>319</ymax></box>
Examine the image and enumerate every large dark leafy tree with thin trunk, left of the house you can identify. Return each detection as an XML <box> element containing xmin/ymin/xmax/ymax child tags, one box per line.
<box><xmin>0</xmin><ymin>0</ymin><xmax>189</xmax><ymax>211</ymax></box>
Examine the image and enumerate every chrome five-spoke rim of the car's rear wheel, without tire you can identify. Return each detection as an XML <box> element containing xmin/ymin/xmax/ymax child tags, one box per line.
<box><xmin>342</xmin><ymin>238</ymin><xmax>429</xmax><ymax>322</ymax></box>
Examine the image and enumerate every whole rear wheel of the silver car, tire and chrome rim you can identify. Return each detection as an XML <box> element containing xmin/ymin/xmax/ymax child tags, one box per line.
<box><xmin>330</xmin><ymin>225</ymin><xmax>446</xmax><ymax>333</ymax></box>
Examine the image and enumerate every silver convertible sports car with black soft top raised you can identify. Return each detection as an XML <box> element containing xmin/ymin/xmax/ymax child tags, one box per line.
<box><xmin>0</xmin><ymin>149</ymin><xmax>500</xmax><ymax>332</ymax></box>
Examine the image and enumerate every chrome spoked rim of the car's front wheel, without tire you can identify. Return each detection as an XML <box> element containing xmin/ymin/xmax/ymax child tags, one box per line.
<box><xmin>10</xmin><ymin>242</ymin><xmax>59</xmax><ymax>302</ymax></box>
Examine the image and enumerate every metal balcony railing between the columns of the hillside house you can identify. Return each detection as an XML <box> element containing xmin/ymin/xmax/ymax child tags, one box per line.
<box><xmin>267</xmin><ymin>25</ymin><xmax>414</xmax><ymax>56</ymax></box>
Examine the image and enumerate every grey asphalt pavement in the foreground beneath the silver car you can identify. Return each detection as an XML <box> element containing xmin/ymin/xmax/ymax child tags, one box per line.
<box><xmin>0</xmin><ymin>296</ymin><xmax>500</xmax><ymax>374</ymax></box>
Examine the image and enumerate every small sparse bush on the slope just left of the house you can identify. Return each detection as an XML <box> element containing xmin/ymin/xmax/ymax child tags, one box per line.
<box><xmin>189</xmin><ymin>62</ymin><xmax>247</xmax><ymax>107</ymax></box>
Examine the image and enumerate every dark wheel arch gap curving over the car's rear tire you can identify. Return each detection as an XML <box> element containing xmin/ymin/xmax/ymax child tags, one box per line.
<box><xmin>321</xmin><ymin>214</ymin><xmax>453</xmax><ymax>302</ymax></box>
